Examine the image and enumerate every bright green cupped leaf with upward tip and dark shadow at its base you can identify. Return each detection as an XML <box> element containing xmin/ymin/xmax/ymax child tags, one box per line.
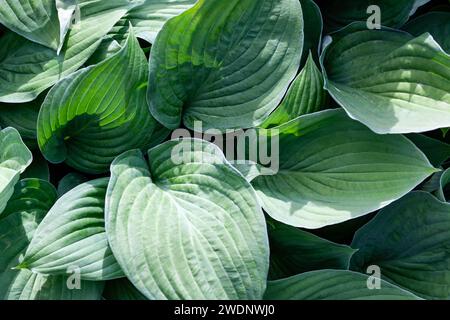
<box><xmin>37</xmin><ymin>33</ymin><xmax>160</xmax><ymax>173</ymax></box>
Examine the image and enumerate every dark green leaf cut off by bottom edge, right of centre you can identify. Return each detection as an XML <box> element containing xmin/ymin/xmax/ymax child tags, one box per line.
<box><xmin>264</xmin><ymin>270</ymin><xmax>419</xmax><ymax>300</ymax></box>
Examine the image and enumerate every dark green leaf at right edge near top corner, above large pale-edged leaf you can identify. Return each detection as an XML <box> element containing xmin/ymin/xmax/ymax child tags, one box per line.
<box><xmin>403</xmin><ymin>11</ymin><xmax>450</xmax><ymax>53</ymax></box>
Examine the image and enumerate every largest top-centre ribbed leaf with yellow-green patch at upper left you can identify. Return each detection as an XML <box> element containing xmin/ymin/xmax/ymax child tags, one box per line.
<box><xmin>148</xmin><ymin>0</ymin><xmax>303</xmax><ymax>130</ymax></box>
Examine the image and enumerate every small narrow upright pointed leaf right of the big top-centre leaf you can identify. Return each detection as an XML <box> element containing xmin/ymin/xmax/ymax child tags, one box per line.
<box><xmin>261</xmin><ymin>52</ymin><xmax>326</xmax><ymax>128</ymax></box>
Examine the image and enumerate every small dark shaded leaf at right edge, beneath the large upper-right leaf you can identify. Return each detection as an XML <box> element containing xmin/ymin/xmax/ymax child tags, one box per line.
<box><xmin>406</xmin><ymin>133</ymin><xmax>450</xmax><ymax>167</ymax></box>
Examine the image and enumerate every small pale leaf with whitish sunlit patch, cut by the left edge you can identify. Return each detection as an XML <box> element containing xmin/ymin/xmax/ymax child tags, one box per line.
<box><xmin>0</xmin><ymin>128</ymin><xmax>33</xmax><ymax>214</ymax></box>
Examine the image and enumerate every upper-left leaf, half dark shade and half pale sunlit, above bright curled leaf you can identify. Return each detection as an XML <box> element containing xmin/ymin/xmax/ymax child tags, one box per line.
<box><xmin>0</xmin><ymin>0</ymin><xmax>131</xmax><ymax>103</ymax></box>
